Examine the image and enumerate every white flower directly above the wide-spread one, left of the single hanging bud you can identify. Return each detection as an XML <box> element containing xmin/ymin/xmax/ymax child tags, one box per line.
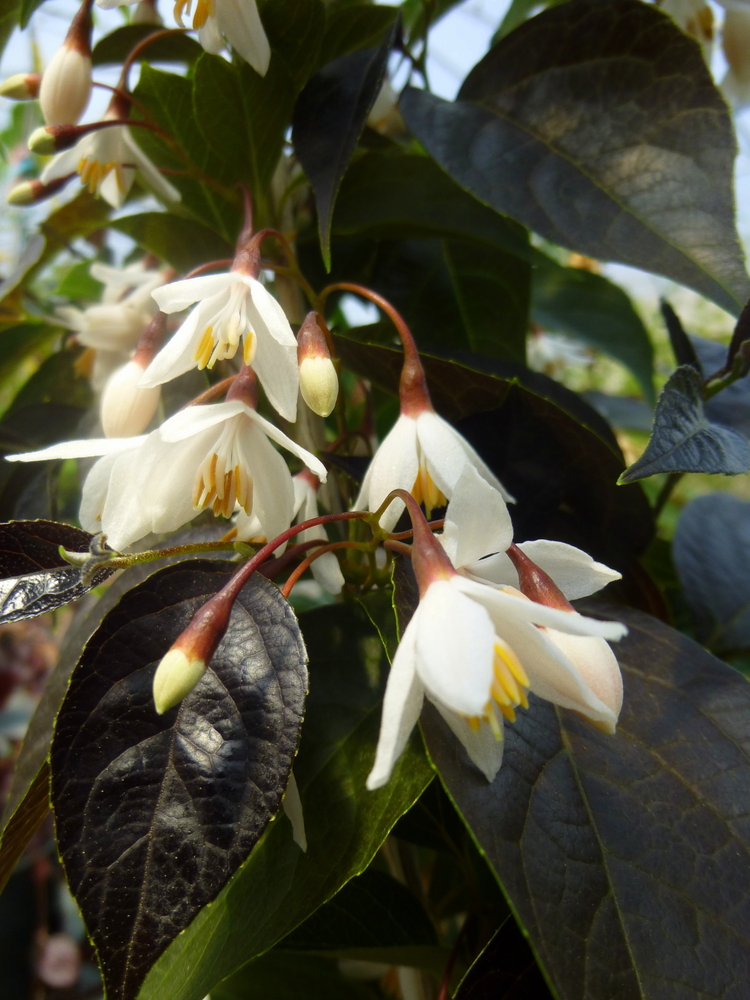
<box><xmin>142</xmin><ymin>271</ymin><xmax>299</xmax><ymax>421</ymax></box>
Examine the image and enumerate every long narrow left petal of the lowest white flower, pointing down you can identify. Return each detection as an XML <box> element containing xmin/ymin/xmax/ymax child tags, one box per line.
<box><xmin>367</xmin><ymin>608</ymin><xmax>424</xmax><ymax>791</ymax></box>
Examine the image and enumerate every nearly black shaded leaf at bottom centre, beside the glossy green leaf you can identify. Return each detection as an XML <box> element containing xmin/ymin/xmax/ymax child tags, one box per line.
<box><xmin>281</xmin><ymin>868</ymin><xmax>437</xmax><ymax>952</ymax></box>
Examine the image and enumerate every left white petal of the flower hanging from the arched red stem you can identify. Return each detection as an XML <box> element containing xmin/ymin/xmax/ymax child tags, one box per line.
<box><xmin>353</xmin><ymin>414</ymin><xmax>419</xmax><ymax>531</ymax></box>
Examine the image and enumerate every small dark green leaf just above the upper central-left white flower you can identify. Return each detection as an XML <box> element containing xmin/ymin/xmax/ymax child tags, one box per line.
<box><xmin>111</xmin><ymin>212</ymin><xmax>234</xmax><ymax>273</ymax></box>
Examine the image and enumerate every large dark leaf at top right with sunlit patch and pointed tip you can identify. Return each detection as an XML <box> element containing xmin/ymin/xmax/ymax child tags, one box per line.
<box><xmin>401</xmin><ymin>0</ymin><xmax>750</xmax><ymax>312</ymax></box>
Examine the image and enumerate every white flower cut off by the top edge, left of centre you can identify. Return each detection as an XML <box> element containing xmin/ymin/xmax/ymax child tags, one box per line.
<box><xmin>96</xmin><ymin>0</ymin><xmax>271</xmax><ymax>76</ymax></box>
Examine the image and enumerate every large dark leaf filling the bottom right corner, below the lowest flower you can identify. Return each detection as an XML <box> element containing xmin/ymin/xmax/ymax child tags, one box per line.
<box><xmin>423</xmin><ymin>606</ymin><xmax>750</xmax><ymax>1000</ymax></box>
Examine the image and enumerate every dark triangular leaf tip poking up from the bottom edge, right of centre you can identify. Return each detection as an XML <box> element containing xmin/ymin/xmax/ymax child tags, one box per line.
<box><xmin>455</xmin><ymin>917</ymin><xmax>553</xmax><ymax>1000</ymax></box>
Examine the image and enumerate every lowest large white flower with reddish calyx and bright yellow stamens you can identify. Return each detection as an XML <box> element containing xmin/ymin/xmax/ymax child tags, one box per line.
<box><xmin>367</xmin><ymin>480</ymin><xmax>627</xmax><ymax>789</ymax></box>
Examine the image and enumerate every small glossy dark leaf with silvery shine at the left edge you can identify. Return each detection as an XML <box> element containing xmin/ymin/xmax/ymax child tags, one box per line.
<box><xmin>0</xmin><ymin>521</ymin><xmax>112</xmax><ymax>625</ymax></box>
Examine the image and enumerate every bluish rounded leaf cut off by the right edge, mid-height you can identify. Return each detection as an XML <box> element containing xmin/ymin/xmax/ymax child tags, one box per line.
<box><xmin>672</xmin><ymin>493</ymin><xmax>750</xmax><ymax>650</ymax></box>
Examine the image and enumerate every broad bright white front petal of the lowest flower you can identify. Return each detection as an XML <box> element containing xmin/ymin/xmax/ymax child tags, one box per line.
<box><xmin>415</xmin><ymin>577</ymin><xmax>495</xmax><ymax>716</ymax></box>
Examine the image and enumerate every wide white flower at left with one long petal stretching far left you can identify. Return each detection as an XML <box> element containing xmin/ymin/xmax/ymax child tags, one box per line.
<box><xmin>10</xmin><ymin>400</ymin><xmax>326</xmax><ymax>549</ymax></box>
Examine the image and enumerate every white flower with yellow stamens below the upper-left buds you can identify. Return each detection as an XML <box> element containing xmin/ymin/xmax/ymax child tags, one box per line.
<box><xmin>40</xmin><ymin>112</ymin><xmax>180</xmax><ymax>208</ymax></box>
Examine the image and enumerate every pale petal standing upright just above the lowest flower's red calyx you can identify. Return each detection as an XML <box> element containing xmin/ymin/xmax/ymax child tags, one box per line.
<box><xmin>439</xmin><ymin>463</ymin><xmax>518</xmax><ymax>568</ymax></box>
